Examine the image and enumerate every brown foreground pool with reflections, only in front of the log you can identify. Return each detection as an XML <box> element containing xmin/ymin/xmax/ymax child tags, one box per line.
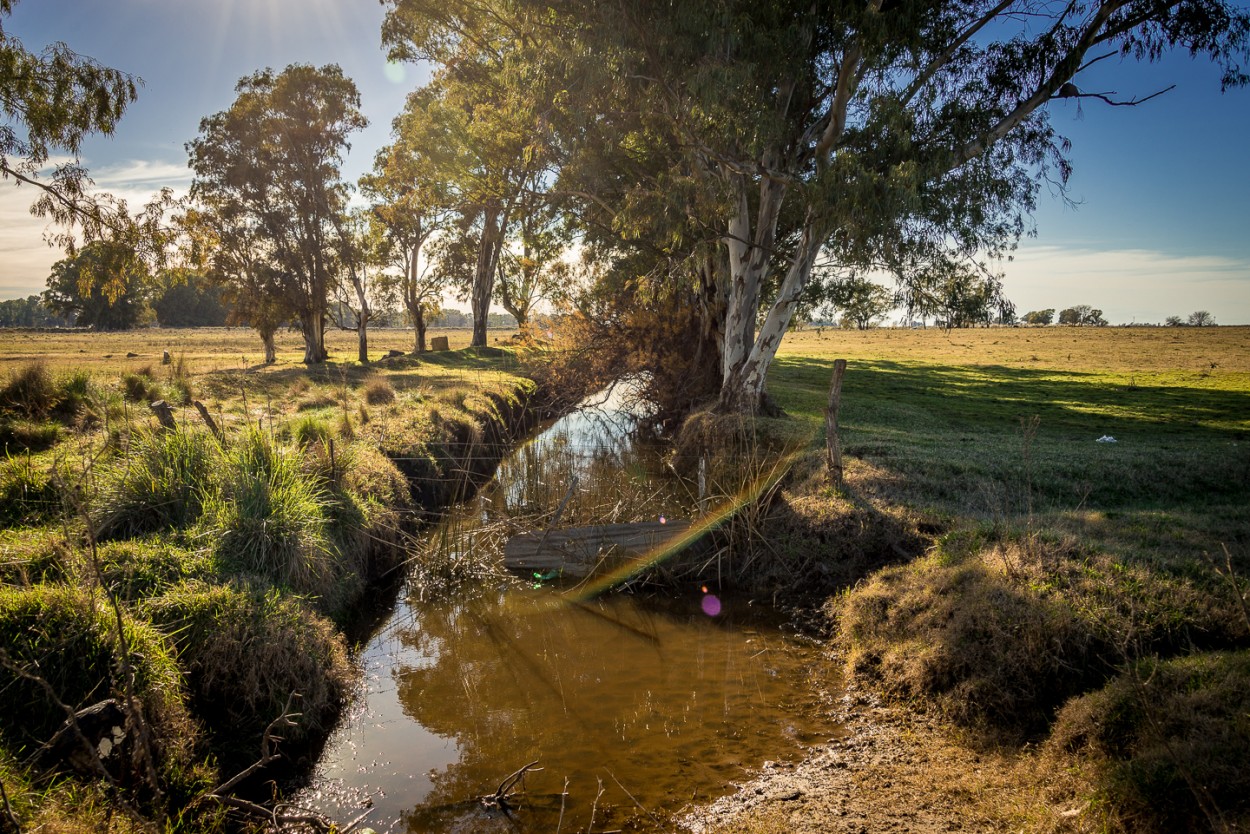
<box><xmin>307</xmin><ymin>590</ymin><xmax>830</xmax><ymax>831</ymax></box>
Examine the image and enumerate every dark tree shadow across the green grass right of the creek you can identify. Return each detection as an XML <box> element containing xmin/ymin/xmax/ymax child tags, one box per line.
<box><xmin>770</xmin><ymin>356</ymin><xmax>1250</xmax><ymax>519</ymax></box>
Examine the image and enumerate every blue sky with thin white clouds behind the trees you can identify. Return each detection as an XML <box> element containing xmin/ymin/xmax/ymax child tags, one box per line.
<box><xmin>0</xmin><ymin>0</ymin><xmax>1250</xmax><ymax>324</ymax></box>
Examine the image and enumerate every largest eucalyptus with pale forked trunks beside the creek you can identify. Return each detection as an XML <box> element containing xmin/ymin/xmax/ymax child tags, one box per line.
<box><xmin>532</xmin><ymin>0</ymin><xmax>1250</xmax><ymax>413</ymax></box>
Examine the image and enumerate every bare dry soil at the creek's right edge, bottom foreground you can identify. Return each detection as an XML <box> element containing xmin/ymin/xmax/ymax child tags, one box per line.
<box><xmin>679</xmin><ymin>684</ymin><xmax>1094</xmax><ymax>834</ymax></box>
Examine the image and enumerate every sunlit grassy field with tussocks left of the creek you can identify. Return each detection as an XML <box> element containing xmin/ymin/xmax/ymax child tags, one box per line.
<box><xmin>0</xmin><ymin>329</ymin><xmax>536</xmax><ymax>831</ymax></box>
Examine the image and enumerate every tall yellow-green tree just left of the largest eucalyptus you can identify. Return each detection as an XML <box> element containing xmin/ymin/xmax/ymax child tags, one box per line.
<box><xmin>383</xmin><ymin>0</ymin><xmax>559</xmax><ymax>346</ymax></box>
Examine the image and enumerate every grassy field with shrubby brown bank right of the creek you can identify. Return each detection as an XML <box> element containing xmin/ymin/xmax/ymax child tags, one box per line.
<box><xmin>730</xmin><ymin>328</ymin><xmax>1250</xmax><ymax>831</ymax></box>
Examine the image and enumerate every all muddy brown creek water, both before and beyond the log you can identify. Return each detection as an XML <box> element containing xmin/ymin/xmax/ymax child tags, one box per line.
<box><xmin>298</xmin><ymin>387</ymin><xmax>836</xmax><ymax>833</ymax></box>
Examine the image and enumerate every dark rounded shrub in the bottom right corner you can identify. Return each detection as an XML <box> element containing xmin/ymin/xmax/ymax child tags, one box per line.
<box><xmin>1048</xmin><ymin>651</ymin><xmax>1250</xmax><ymax>831</ymax></box>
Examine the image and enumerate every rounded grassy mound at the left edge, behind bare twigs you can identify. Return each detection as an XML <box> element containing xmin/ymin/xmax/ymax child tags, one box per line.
<box><xmin>0</xmin><ymin>585</ymin><xmax>190</xmax><ymax>765</ymax></box>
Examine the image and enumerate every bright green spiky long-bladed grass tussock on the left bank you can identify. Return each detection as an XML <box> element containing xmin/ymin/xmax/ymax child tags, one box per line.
<box><xmin>208</xmin><ymin>430</ymin><xmax>335</xmax><ymax>596</ymax></box>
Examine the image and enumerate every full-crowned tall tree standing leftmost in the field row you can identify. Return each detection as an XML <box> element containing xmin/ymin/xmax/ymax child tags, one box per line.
<box><xmin>188</xmin><ymin>64</ymin><xmax>368</xmax><ymax>364</ymax></box>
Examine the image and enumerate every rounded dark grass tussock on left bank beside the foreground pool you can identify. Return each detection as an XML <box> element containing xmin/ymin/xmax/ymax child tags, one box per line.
<box><xmin>141</xmin><ymin>583</ymin><xmax>355</xmax><ymax>764</ymax></box>
